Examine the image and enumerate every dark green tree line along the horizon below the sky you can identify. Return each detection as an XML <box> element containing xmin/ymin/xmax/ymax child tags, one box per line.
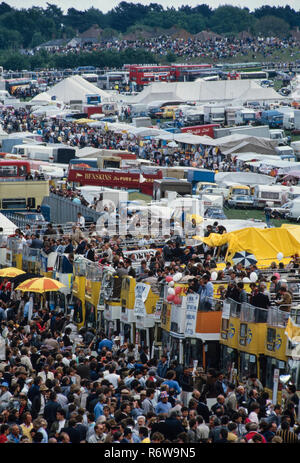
<box><xmin>0</xmin><ymin>1</ymin><xmax>300</xmax><ymax>50</ymax></box>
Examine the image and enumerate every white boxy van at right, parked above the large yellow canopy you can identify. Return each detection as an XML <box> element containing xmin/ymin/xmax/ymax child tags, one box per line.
<box><xmin>253</xmin><ymin>185</ymin><xmax>289</xmax><ymax>209</ymax></box>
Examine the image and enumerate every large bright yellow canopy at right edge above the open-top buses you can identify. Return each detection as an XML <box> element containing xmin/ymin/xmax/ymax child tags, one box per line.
<box><xmin>194</xmin><ymin>224</ymin><xmax>300</xmax><ymax>265</ymax></box>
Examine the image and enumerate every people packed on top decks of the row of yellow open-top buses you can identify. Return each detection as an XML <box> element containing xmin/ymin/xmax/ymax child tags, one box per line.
<box><xmin>8</xmin><ymin>218</ymin><xmax>300</xmax><ymax>323</ymax></box>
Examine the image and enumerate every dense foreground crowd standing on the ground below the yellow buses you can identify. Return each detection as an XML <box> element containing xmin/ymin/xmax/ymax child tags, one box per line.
<box><xmin>0</xmin><ymin>294</ymin><xmax>300</xmax><ymax>444</ymax></box>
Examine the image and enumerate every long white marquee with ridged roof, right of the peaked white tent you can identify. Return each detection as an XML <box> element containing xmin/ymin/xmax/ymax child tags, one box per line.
<box><xmin>128</xmin><ymin>79</ymin><xmax>284</xmax><ymax>104</ymax></box>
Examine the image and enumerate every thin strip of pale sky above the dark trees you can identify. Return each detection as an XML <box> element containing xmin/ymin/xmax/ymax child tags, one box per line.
<box><xmin>3</xmin><ymin>0</ymin><xmax>300</xmax><ymax>13</ymax></box>
